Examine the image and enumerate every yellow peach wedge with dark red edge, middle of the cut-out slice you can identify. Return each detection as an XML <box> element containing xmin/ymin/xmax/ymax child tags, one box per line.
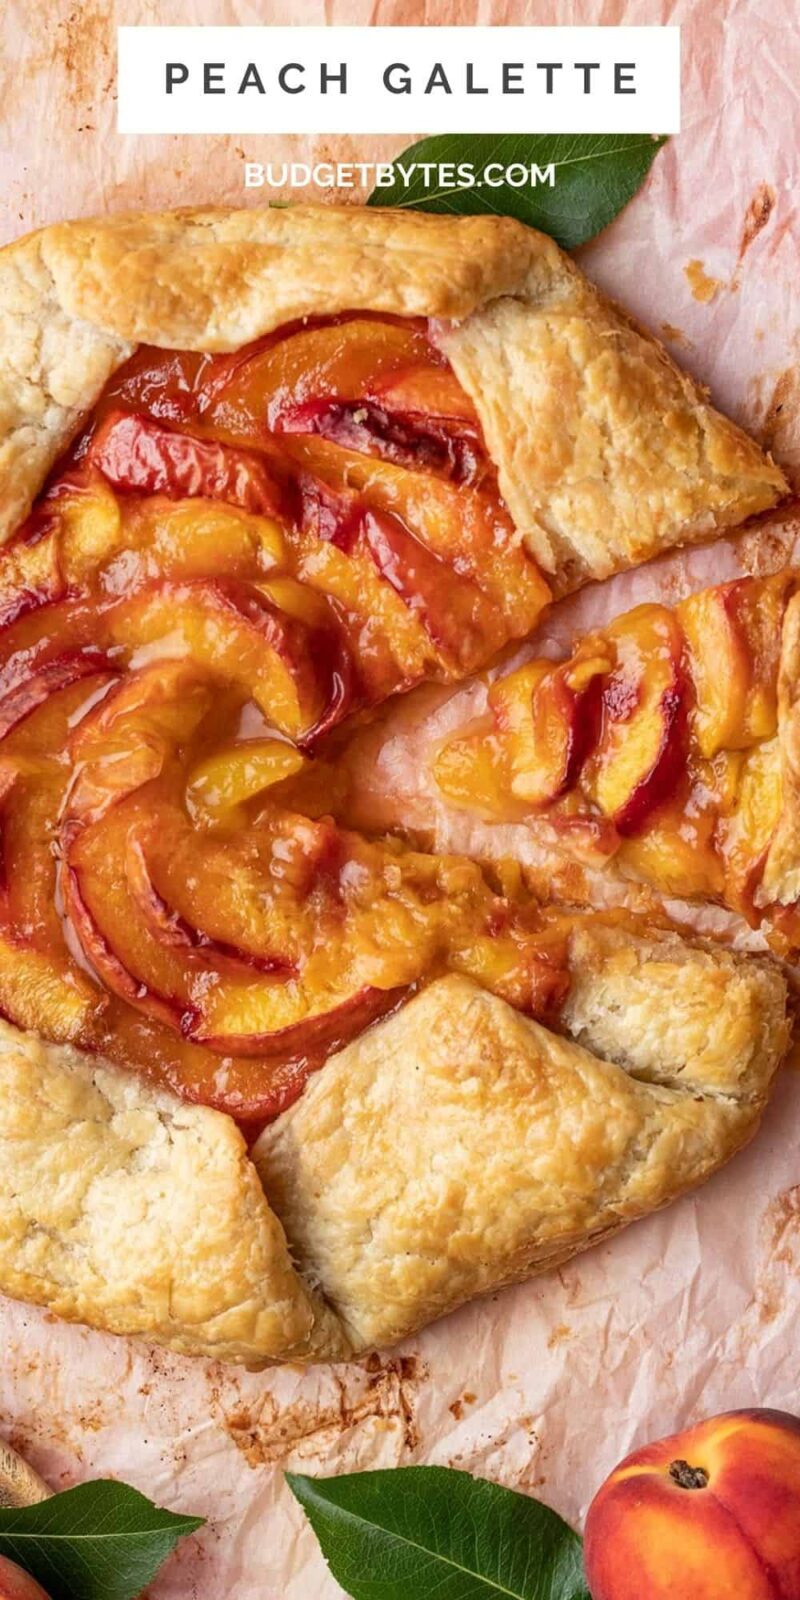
<box><xmin>584</xmin><ymin>605</ymin><xmax>686</xmax><ymax>837</ymax></box>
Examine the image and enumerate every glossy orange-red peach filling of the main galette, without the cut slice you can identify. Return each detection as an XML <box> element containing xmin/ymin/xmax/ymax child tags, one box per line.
<box><xmin>0</xmin><ymin>308</ymin><xmax>566</xmax><ymax>1120</ymax></box>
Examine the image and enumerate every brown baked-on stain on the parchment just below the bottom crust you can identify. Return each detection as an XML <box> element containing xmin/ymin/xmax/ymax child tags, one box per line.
<box><xmin>216</xmin><ymin>1354</ymin><xmax>427</xmax><ymax>1467</ymax></box>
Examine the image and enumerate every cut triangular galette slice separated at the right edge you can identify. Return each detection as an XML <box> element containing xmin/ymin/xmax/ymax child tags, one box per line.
<box><xmin>435</xmin><ymin>573</ymin><xmax>795</xmax><ymax>923</ymax></box>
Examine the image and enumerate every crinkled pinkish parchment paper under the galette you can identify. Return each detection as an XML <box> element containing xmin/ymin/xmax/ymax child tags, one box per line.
<box><xmin>0</xmin><ymin>0</ymin><xmax>800</xmax><ymax>1600</ymax></box>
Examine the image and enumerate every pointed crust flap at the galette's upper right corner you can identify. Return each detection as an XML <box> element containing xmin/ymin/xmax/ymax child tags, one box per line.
<box><xmin>442</xmin><ymin>289</ymin><xmax>787</xmax><ymax>594</ymax></box>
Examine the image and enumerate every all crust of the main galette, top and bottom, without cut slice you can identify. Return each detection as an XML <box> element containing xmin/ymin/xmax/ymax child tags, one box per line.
<box><xmin>0</xmin><ymin>206</ymin><xmax>786</xmax><ymax>1365</ymax></box>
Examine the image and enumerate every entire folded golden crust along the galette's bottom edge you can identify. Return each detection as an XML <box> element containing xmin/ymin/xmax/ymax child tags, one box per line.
<box><xmin>0</xmin><ymin>920</ymin><xmax>787</xmax><ymax>1366</ymax></box>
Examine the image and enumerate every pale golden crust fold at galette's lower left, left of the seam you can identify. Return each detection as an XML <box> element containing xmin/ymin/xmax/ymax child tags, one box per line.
<box><xmin>0</xmin><ymin>1024</ymin><xmax>347</xmax><ymax>1365</ymax></box>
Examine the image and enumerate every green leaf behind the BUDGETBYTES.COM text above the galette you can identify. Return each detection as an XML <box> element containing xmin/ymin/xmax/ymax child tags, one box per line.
<box><xmin>366</xmin><ymin>133</ymin><xmax>666</xmax><ymax>250</ymax></box>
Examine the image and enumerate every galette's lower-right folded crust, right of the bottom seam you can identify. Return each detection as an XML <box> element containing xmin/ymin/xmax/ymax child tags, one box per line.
<box><xmin>254</xmin><ymin>930</ymin><xmax>786</xmax><ymax>1346</ymax></box>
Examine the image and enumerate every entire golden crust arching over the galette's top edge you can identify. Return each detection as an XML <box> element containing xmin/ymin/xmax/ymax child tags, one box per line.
<box><xmin>0</xmin><ymin>206</ymin><xmax>786</xmax><ymax>569</ymax></box>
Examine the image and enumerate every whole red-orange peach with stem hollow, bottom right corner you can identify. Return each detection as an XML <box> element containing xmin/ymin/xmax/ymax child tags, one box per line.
<box><xmin>584</xmin><ymin>1411</ymin><xmax>800</xmax><ymax>1600</ymax></box>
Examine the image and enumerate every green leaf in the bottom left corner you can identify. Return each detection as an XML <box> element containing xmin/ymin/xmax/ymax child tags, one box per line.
<box><xmin>0</xmin><ymin>1478</ymin><xmax>203</xmax><ymax>1600</ymax></box>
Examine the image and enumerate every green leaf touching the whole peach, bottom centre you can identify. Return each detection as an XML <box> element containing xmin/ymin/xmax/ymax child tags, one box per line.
<box><xmin>286</xmin><ymin>1467</ymin><xmax>589</xmax><ymax>1600</ymax></box>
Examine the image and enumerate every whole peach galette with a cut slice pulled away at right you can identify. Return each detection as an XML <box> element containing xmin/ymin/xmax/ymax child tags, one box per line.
<box><xmin>0</xmin><ymin>208</ymin><xmax>787</xmax><ymax>1363</ymax></box>
